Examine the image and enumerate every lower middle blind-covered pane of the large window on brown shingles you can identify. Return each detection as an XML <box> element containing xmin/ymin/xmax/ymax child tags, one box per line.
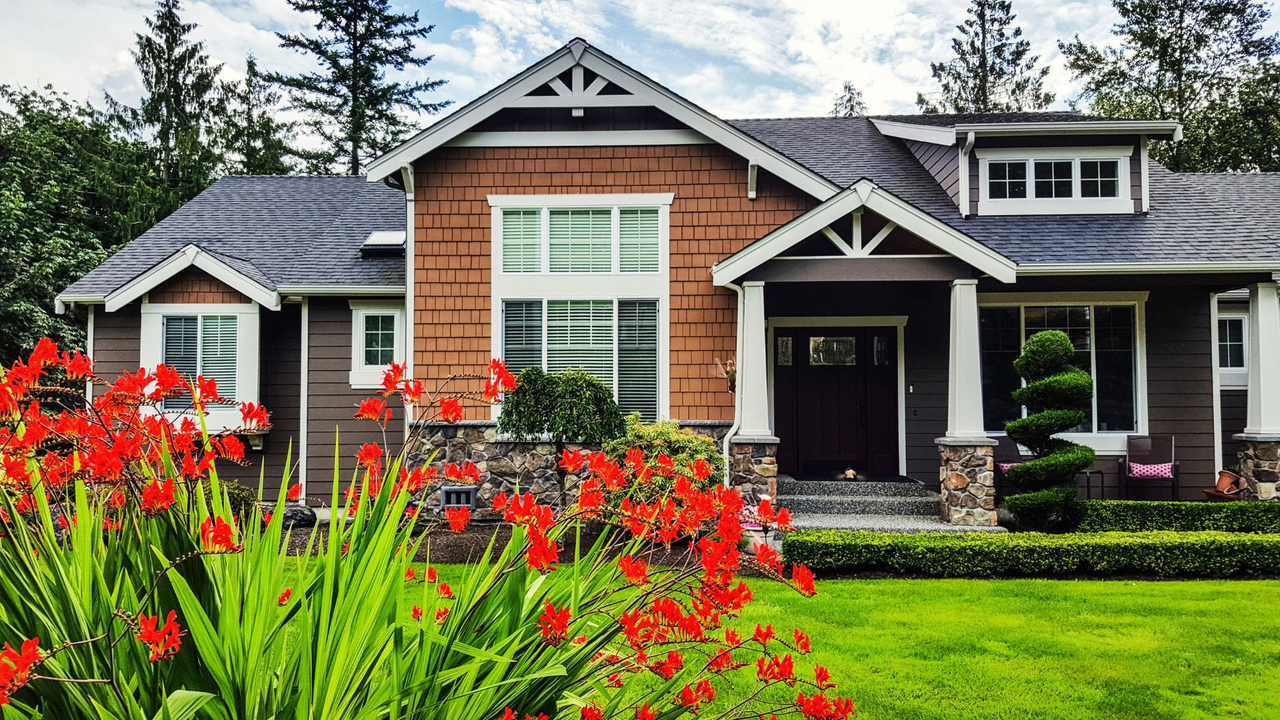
<box><xmin>547</xmin><ymin>300</ymin><xmax>613</xmax><ymax>388</ymax></box>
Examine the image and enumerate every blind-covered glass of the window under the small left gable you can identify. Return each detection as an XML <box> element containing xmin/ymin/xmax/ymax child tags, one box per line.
<box><xmin>161</xmin><ymin>315</ymin><xmax>239</xmax><ymax>410</ymax></box>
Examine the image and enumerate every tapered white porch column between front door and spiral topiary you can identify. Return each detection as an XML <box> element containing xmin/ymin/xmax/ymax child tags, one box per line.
<box><xmin>946</xmin><ymin>279</ymin><xmax>987</xmax><ymax>445</ymax></box>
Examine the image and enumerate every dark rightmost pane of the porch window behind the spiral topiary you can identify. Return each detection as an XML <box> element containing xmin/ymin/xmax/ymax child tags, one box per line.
<box><xmin>1093</xmin><ymin>306</ymin><xmax>1138</xmax><ymax>432</ymax></box>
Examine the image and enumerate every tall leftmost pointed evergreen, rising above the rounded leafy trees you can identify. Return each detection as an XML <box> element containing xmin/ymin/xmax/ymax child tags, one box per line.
<box><xmin>106</xmin><ymin>0</ymin><xmax>223</xmax><ymax>202</ymax></box>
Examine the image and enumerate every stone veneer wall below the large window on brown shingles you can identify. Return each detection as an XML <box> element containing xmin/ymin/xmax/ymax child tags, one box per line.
<box><xmin>408</xmin><ymin>420</ymin><xmax>732</xmax><ymax>519</ymax></box>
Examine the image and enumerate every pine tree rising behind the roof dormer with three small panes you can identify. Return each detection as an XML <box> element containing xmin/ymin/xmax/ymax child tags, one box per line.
<box><xmin>915</xmin><ymin>0</ymin><xmax>1053</xmax><ymax>113</ymax></box>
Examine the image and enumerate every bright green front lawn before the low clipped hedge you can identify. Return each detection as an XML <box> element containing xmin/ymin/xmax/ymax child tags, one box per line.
<box><xmin>721</xmin><ymin>580</ymin><xmax>1280</xmax><ymax>720</ymax></box>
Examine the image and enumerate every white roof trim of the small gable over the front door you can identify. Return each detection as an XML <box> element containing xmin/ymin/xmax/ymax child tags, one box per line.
<box><xmin>712</xmin><ymin>179</ymin><xmax>1016</xmax><ymax>286</ymax></box>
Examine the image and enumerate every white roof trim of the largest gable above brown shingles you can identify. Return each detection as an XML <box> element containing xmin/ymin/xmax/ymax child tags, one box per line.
<box><xmin>366</xmin><ymin>40</ymin><xmax>840</xmax><ymax>200</ymax></box>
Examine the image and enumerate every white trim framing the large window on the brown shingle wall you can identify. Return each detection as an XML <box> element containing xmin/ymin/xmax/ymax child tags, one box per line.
<box><xmin>489</xmin><ymin>192</ymin><xmax>675</xmax><ymax>419</ymax></box>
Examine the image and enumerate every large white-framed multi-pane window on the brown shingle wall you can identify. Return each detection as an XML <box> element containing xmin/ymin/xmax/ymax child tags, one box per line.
<box><xmin>489</xmin><ymin>193</ymin><xmax>673</xmax><ymax>419</ymax></box>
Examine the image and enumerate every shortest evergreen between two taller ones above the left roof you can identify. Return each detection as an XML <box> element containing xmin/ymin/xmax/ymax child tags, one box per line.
<box><xmin>223</xmin><ymin>53</ymin><xmax>294</xmax><ymax>176</ymax></box>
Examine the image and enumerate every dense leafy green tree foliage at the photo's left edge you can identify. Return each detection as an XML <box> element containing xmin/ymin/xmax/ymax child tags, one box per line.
<box><xmin>0</xmin><ymin>86</ymin><xmax>169</xmax><ymax>363</ymax></box>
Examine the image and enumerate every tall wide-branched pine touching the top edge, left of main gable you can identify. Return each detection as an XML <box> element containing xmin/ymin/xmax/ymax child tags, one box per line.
<box><xmin>269</xmin><ymin>0</ymin><xmax>448</xmax><ymax>176</ymax></box>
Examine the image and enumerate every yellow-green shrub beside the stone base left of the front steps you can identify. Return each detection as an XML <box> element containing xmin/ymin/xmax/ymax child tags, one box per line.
<box><xmin>602</xmin><ymin>413</ymin><xmax>724</xmax><ymax>501</ymax></box>
